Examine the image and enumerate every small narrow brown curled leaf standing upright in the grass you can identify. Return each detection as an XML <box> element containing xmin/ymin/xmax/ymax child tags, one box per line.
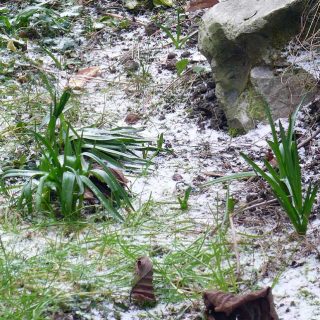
<box><xmin>130</xmin><ymin>256</ymin><xmax>156</xmax><ymax>304</ymax></box>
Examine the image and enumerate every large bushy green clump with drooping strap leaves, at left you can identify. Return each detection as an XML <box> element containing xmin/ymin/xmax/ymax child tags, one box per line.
<box><xmin>1</xmin><ymin>86</ymin><xmax>155</xmax><ymax>221</ymax></box>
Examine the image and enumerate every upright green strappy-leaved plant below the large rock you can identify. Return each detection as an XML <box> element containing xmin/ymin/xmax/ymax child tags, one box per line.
<box><xmin>241</xmin><ymin>108</ymin><xmax>318</xmax><ymax>235</ymax></box>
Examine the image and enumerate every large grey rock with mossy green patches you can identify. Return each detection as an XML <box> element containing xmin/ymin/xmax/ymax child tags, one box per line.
<box><xmin>199</xmin><ymin>0</ymin><xmax>318</xmax><ymax>130</ymax></box>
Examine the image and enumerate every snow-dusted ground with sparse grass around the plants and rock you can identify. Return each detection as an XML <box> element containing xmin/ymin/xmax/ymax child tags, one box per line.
<box><xmin>0</xmin><ymin>1</ymin><xmax>320</xmax><ymax>320</ymax></box>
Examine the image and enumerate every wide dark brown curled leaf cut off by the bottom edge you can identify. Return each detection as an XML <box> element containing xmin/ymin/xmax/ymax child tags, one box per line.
<box><xmin>203</xmin><ymin>288</ymin><xmax>279</xmax><ymax>320</ymax></box>
